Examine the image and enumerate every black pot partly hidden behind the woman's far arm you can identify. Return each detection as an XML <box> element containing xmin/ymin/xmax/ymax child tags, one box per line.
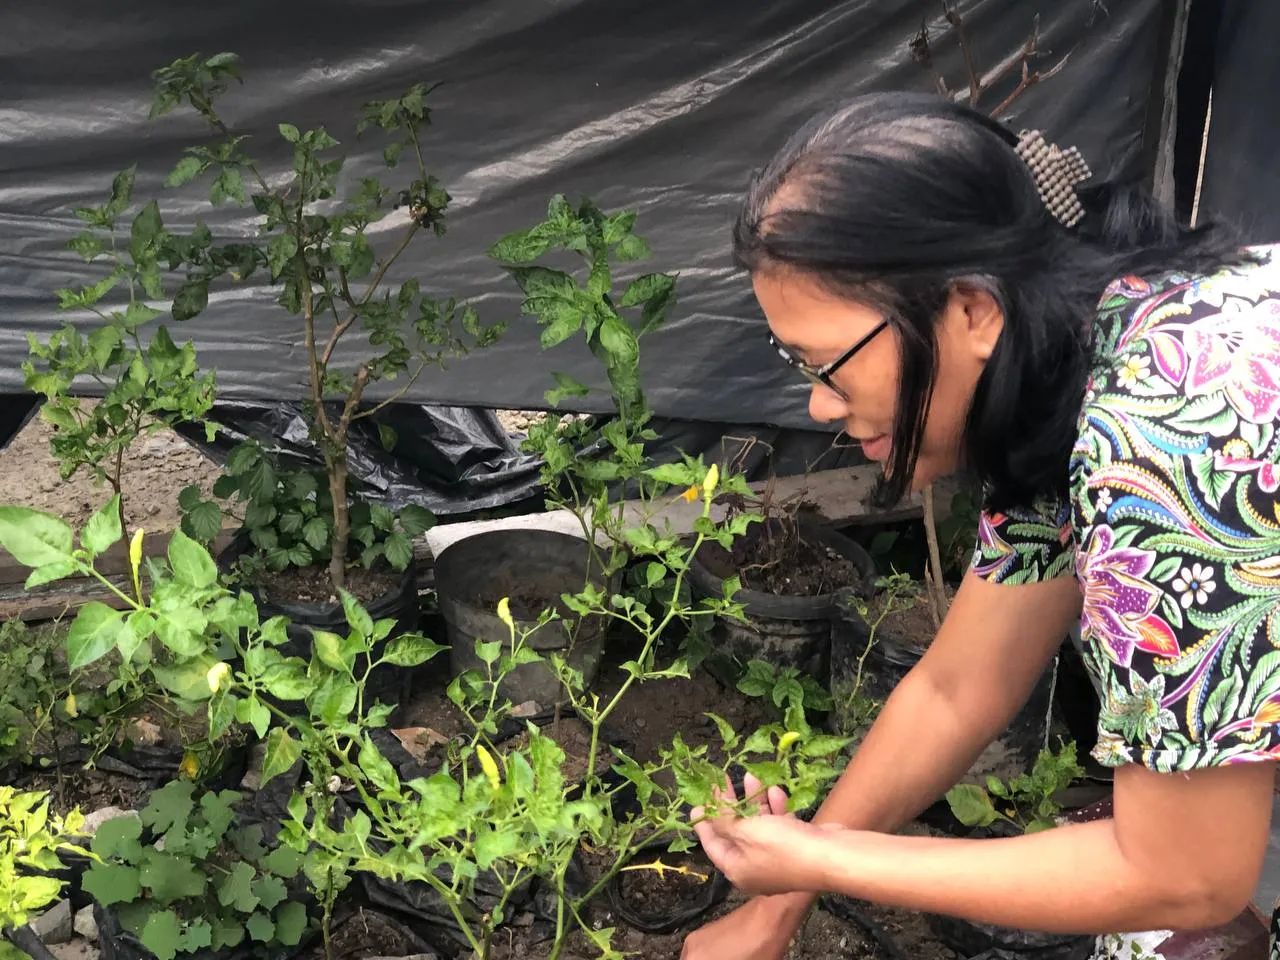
<box><xmin>831</xmin><ymin>591</ymin><xmax>1057</xmax><ymax>783</ymax></box>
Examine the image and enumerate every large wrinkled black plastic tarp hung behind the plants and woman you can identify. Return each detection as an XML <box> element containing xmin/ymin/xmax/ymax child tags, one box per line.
<box><xmin>0</xmin><ymin>0</ymin><xmax>1165</xmax><ymax>432</ymax></box>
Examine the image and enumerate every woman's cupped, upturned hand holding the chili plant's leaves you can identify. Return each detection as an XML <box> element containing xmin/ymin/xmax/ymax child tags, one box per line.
<box><xmin>691</xmin><ymin>774</ymin><xmax>840</xmax><ymax>895</ymax></box>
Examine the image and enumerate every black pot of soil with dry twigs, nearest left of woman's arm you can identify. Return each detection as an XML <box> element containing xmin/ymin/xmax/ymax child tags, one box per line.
<box><xmin>689</xmin><ymin>520</ymin><xmax>876</xmax><ymax>684</ymax></box>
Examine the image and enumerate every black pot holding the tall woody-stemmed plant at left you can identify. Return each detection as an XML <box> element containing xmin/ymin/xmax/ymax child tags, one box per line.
<box><xmin>218</xmin><ymin>530</ymin><xmax>419</xmax><ymax>723</ymax></box>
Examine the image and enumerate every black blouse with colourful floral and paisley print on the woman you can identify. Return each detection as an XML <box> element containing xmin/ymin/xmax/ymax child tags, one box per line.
<box><xmin>973</xmin><ymin>246</ymin><xmax>1280</xmax><ymax>772</ymax></box>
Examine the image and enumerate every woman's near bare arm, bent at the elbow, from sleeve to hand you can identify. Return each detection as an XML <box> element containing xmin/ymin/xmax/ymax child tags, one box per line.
<box><xmin>700</xmin><ymin>763</ymin><xmax>1275</xmax><ymax>933</ymax></box>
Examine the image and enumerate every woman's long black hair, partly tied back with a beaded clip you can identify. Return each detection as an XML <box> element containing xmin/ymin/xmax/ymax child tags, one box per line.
<box><xmin>733</xmin><ymin>92</ymin><xmax>1249</xmax><ymax>509</ymax></box>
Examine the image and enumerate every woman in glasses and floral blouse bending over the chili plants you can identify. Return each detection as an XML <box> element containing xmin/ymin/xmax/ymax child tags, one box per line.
<box><xmin>684</xmin><ymin>93</ymin><xmax>1280</xmax><ymax>960</ymax></box>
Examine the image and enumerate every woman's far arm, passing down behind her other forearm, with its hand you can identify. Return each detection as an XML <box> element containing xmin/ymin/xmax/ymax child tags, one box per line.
<box><xmin>684</xmin><ymin>573</ymin><xmax>1080</xmax><ymax>960</ymax></box>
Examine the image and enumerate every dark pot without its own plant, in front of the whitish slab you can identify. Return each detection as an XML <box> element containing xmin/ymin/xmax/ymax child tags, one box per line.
<box><xmin>435</xmin><ymin>530</ymin><xmax>620</xmax><ymax>707</ymax></box>
